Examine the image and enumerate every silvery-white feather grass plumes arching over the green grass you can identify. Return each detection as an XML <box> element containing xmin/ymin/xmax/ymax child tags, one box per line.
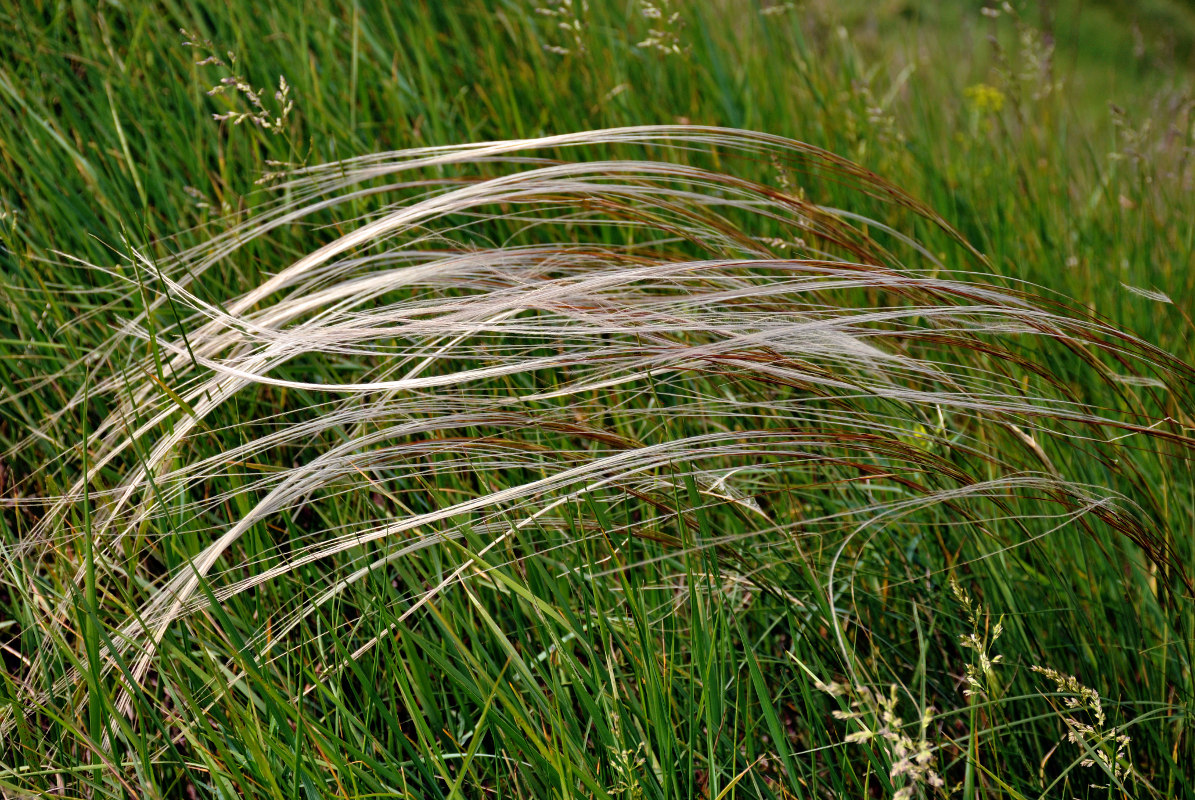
<box><xmin>0</xmin><ymin>127</ymin><xmax>1191</xmax><ymax>750</ymax></box>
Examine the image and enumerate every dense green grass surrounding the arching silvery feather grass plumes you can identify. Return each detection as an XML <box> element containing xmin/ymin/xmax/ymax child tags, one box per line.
<box><xmin>0</xmin><ymin>0</ymin><xmax>1195</xmax><ymax>800</ymax></box>
